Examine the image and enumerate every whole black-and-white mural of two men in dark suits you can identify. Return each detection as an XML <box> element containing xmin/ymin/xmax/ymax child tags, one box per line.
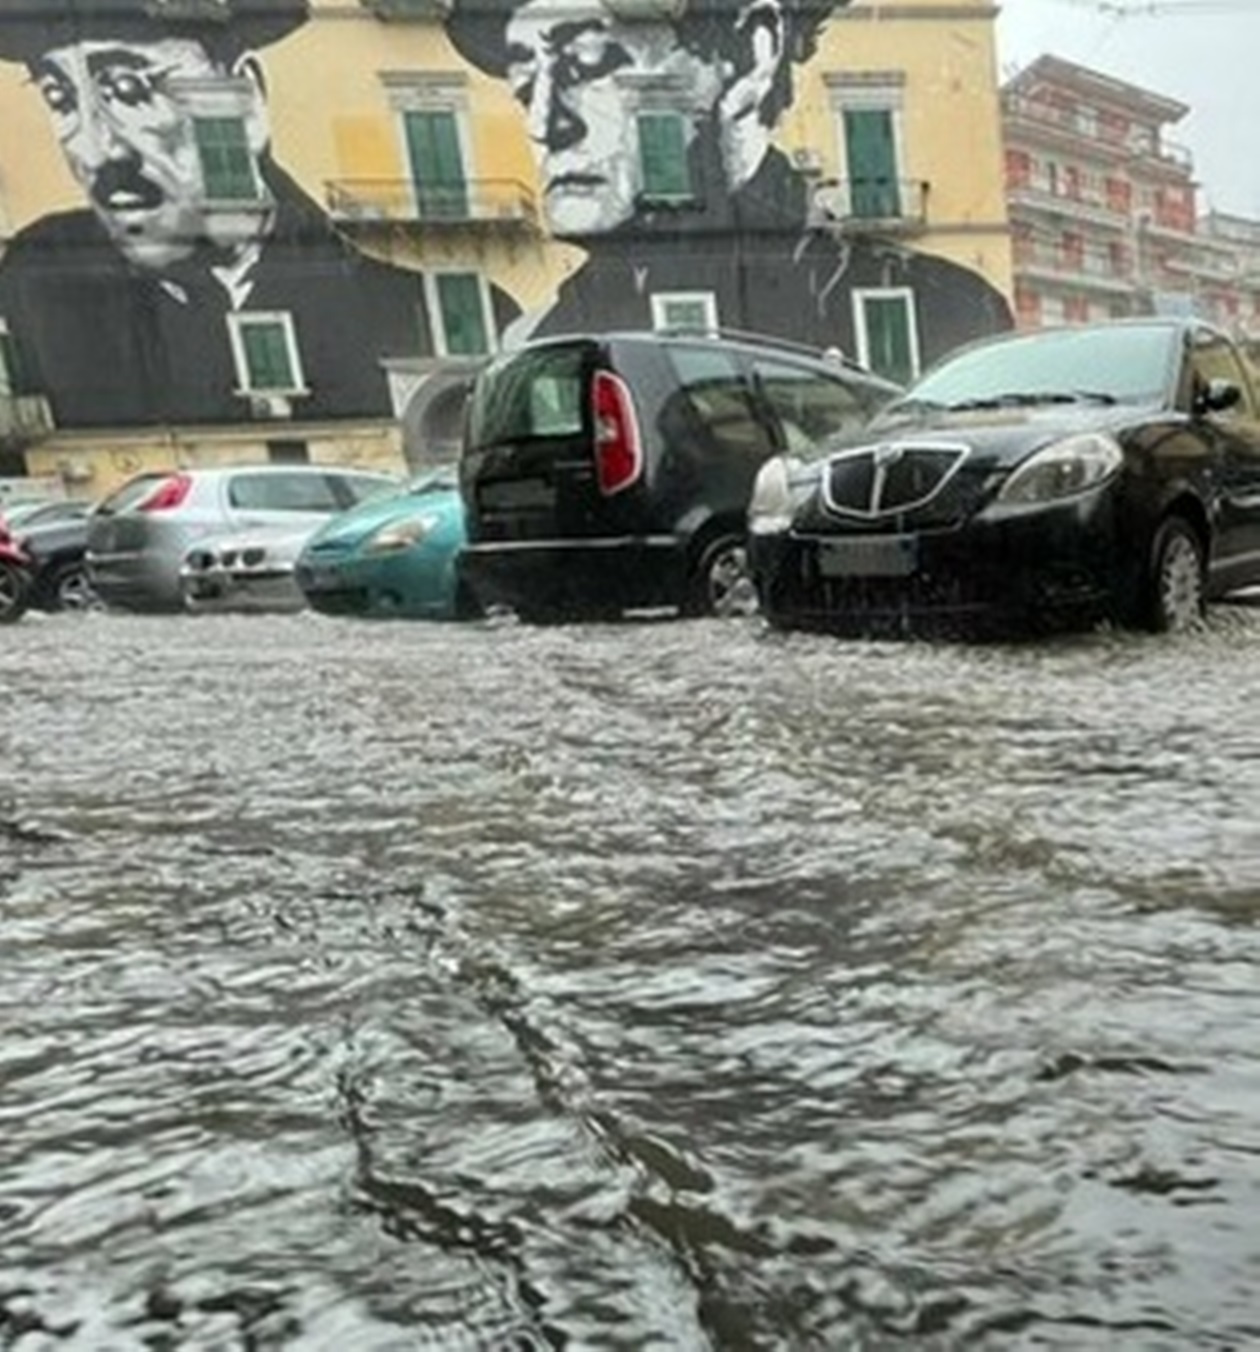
<box><xmin>0</xmin><ymin>0</ymin><xmax>1010</xmax><ymax>427</ymax></box>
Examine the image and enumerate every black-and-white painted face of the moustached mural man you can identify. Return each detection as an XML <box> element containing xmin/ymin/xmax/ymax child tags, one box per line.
<box><xmin>31</xmin><ymin>38</ymin><xmax>266</xmax><ymax>269</ymax></box>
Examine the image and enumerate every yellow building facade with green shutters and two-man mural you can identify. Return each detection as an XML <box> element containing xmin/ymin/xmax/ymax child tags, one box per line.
<box><xmin>0</xmin><ymin>0</ymin><xmax>1011</xmax><ymax>496</ymax></box>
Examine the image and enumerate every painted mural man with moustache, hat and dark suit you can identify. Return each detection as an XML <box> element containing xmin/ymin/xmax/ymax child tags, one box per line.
<box><xmin>0</xmin><ymin>0</ymin><xmax>514</xmax><ymax>427</ymax></box>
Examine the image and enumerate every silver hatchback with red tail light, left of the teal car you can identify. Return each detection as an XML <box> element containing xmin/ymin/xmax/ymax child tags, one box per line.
<box><xmin>87</xmin><ymin>465</ymin><xmax>397</xmax><ymax>611</ymax></box>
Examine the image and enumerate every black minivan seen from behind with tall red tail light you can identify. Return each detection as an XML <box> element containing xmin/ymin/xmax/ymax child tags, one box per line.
<box><xmin>460</xmin><ymin>333</ymin><xmax>900</xmax><ymax>622</ymax></box>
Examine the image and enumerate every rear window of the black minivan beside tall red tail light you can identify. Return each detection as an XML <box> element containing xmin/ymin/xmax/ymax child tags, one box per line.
<box><xmin>468</xmin><ymin>346</ymin><xmax>588</xmax><ymax>446</ymax></box>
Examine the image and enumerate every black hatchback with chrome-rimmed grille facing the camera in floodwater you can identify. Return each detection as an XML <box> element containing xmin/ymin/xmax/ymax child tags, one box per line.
<box><xmin>749</xmin><ymin>318</ymin><xmax>1260</xmax><ymax>633</ymax></box>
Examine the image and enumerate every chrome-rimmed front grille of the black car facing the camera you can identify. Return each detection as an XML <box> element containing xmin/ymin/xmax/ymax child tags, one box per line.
<box><xmin>822</xmin><ymin>441</ymin><xmax>969</xmax><ymax>521</ymax></box>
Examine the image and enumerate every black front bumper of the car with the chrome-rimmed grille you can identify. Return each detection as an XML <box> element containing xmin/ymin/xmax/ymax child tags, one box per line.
<box><xmin>749</xmin><ymin>489</ymin><xmax>1132</xmax><ymax>635</ymax></box>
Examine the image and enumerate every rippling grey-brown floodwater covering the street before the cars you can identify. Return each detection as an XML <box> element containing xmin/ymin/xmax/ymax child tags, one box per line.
<box><xmin>0</xmin><ymin>607</ymin><xmax>1260</xmax><ymax>1352</ymax></box>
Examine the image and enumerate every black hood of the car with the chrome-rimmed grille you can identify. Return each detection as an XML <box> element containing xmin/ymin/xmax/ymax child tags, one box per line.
<box><xmin>838</xmin><ymin>403</ymin><xmax>1156</xmax><ymax>469</ymax></box>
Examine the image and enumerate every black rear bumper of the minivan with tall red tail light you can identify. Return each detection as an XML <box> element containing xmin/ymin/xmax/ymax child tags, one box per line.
<box><xmin>458</xmin><ymin>535</ymin><xmax>687</xmax><ymax>619</ymax></box>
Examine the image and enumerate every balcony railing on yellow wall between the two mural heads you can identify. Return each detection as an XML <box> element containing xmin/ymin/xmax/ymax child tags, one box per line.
<box><xmin>326</xmin><ymin>178</ymin><xmax>538</xmax><ymax>230</ymax></box>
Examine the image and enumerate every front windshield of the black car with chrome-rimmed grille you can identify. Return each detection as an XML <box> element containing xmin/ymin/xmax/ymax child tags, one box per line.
<box><xmin>881</xmin><ymin>324</ymin><xmax>1178</xmax><ymax>419</ymax></box>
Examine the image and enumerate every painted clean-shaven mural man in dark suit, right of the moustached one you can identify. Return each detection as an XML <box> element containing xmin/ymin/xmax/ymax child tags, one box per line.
<box><xmin>446</xmin><ymin>0</ymin><xmax>1011</xmax><ymax>361</ymax></box>
